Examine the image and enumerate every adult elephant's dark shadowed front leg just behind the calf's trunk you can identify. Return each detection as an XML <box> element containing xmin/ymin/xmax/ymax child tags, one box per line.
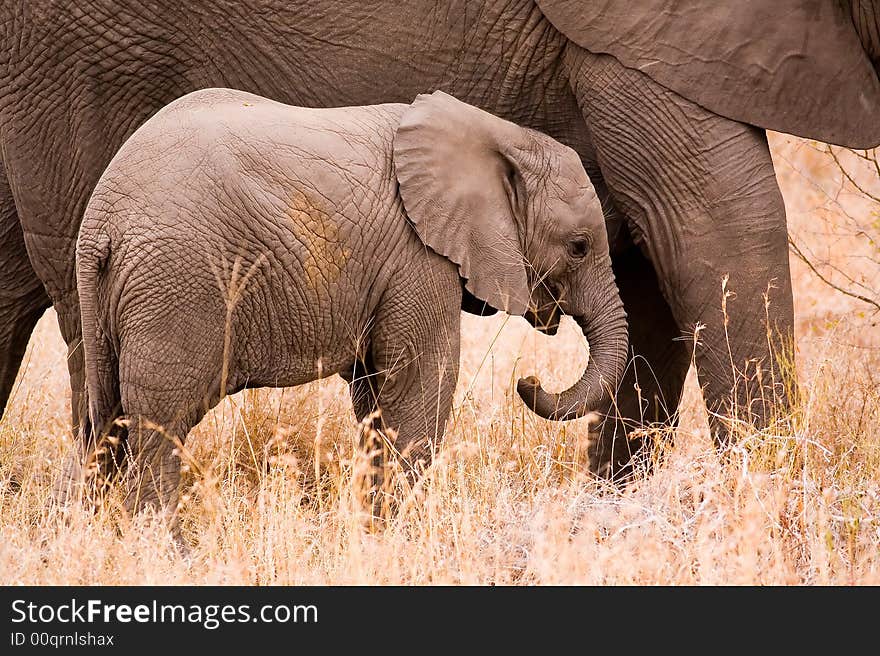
<box><xmin>590</xmin><ymin>246</ymin><xmax>691</xmax><ymax>480</ymax></box>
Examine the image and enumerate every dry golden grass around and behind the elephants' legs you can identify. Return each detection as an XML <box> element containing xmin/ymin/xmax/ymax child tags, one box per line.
<box><xmin>0</xmin><ymin>135</ymin><xmax>880</xmax><ymax>585</ymax></box>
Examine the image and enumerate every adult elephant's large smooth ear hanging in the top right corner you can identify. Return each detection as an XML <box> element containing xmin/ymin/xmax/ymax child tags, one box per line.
<box><xmin>537</xmin><ymin>0</ymin><xmax>880</xmax><ymax>148</ymax></box>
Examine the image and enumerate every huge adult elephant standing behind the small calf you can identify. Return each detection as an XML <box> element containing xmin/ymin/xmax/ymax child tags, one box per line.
<box><xmin>0</xmin><ymin>0</ymin><xmax>880</xmax><ymax>476</ymax></box>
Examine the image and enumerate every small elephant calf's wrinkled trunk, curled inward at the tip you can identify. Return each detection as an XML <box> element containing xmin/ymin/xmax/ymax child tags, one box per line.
<box><xmin>516</xmin><ymin>272</ymin><xmax>628</xmax><ymax>420</ymax></box>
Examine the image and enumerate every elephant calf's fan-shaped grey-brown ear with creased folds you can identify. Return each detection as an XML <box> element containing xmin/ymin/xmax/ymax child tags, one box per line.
<box><xmin>394</xmin><ymin>91</ymin><xmax>529</xmax><ymax>314</ymax></box>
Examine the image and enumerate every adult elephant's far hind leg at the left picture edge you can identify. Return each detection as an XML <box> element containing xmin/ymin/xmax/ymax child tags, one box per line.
<box><xmin>0</xmin><ymin>162</ymin><xmax>51</xmax><ymax>417</ymax></box>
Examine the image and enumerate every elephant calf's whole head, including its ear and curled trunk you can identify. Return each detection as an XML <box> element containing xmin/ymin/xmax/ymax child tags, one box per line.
<box><xmin>394</xmin><ymin>91</ymin><xmax>628</xmax><ymax>419</ymax></box>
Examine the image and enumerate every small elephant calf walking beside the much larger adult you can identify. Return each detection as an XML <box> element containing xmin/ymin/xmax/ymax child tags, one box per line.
<box><xmin>76</xmin><ymin>89</ymin><xmax>627</xmax><ymax>511</ymax></box>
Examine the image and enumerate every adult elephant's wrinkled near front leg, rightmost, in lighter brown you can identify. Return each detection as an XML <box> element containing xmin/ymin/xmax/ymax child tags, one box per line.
<box><xmin>568</xmin><ymin>47</ymin><xmax>793</xmax><ymax>452</ymax></box>
